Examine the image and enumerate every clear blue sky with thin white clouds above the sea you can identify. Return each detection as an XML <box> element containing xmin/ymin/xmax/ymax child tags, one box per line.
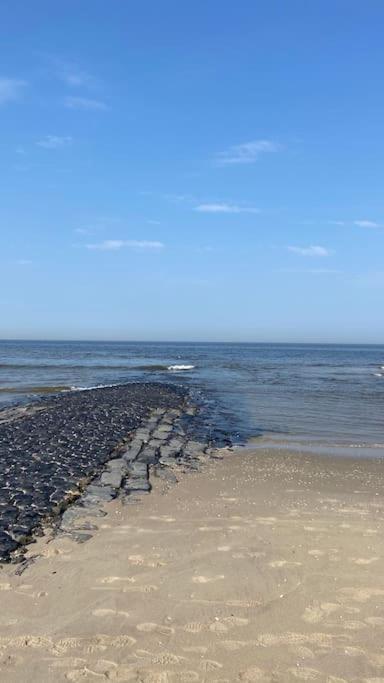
<box><xmin>0</xmin><ymin>0</ymin><xmax>384</xmax><ymax>343</ymax></box>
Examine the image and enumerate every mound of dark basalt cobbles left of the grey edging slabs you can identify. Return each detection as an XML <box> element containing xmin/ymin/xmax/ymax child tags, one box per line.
<box><xmin>0</xmin><ymin>383</ymin><xmax>184</xmax><ymax>559</ymax></box>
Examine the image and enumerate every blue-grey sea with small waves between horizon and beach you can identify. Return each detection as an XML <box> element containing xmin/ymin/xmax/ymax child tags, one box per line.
<box><xmin>0</xmin><ymin>341</ymin><xmax>384</xmax><ymax>455</ymax></box>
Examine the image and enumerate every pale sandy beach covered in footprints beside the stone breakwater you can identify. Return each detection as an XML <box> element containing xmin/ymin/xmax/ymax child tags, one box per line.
<box><xmin>0</xmin><ymin>449</ymin><xmax>384</xmax><ymax>683</ymax></box>
